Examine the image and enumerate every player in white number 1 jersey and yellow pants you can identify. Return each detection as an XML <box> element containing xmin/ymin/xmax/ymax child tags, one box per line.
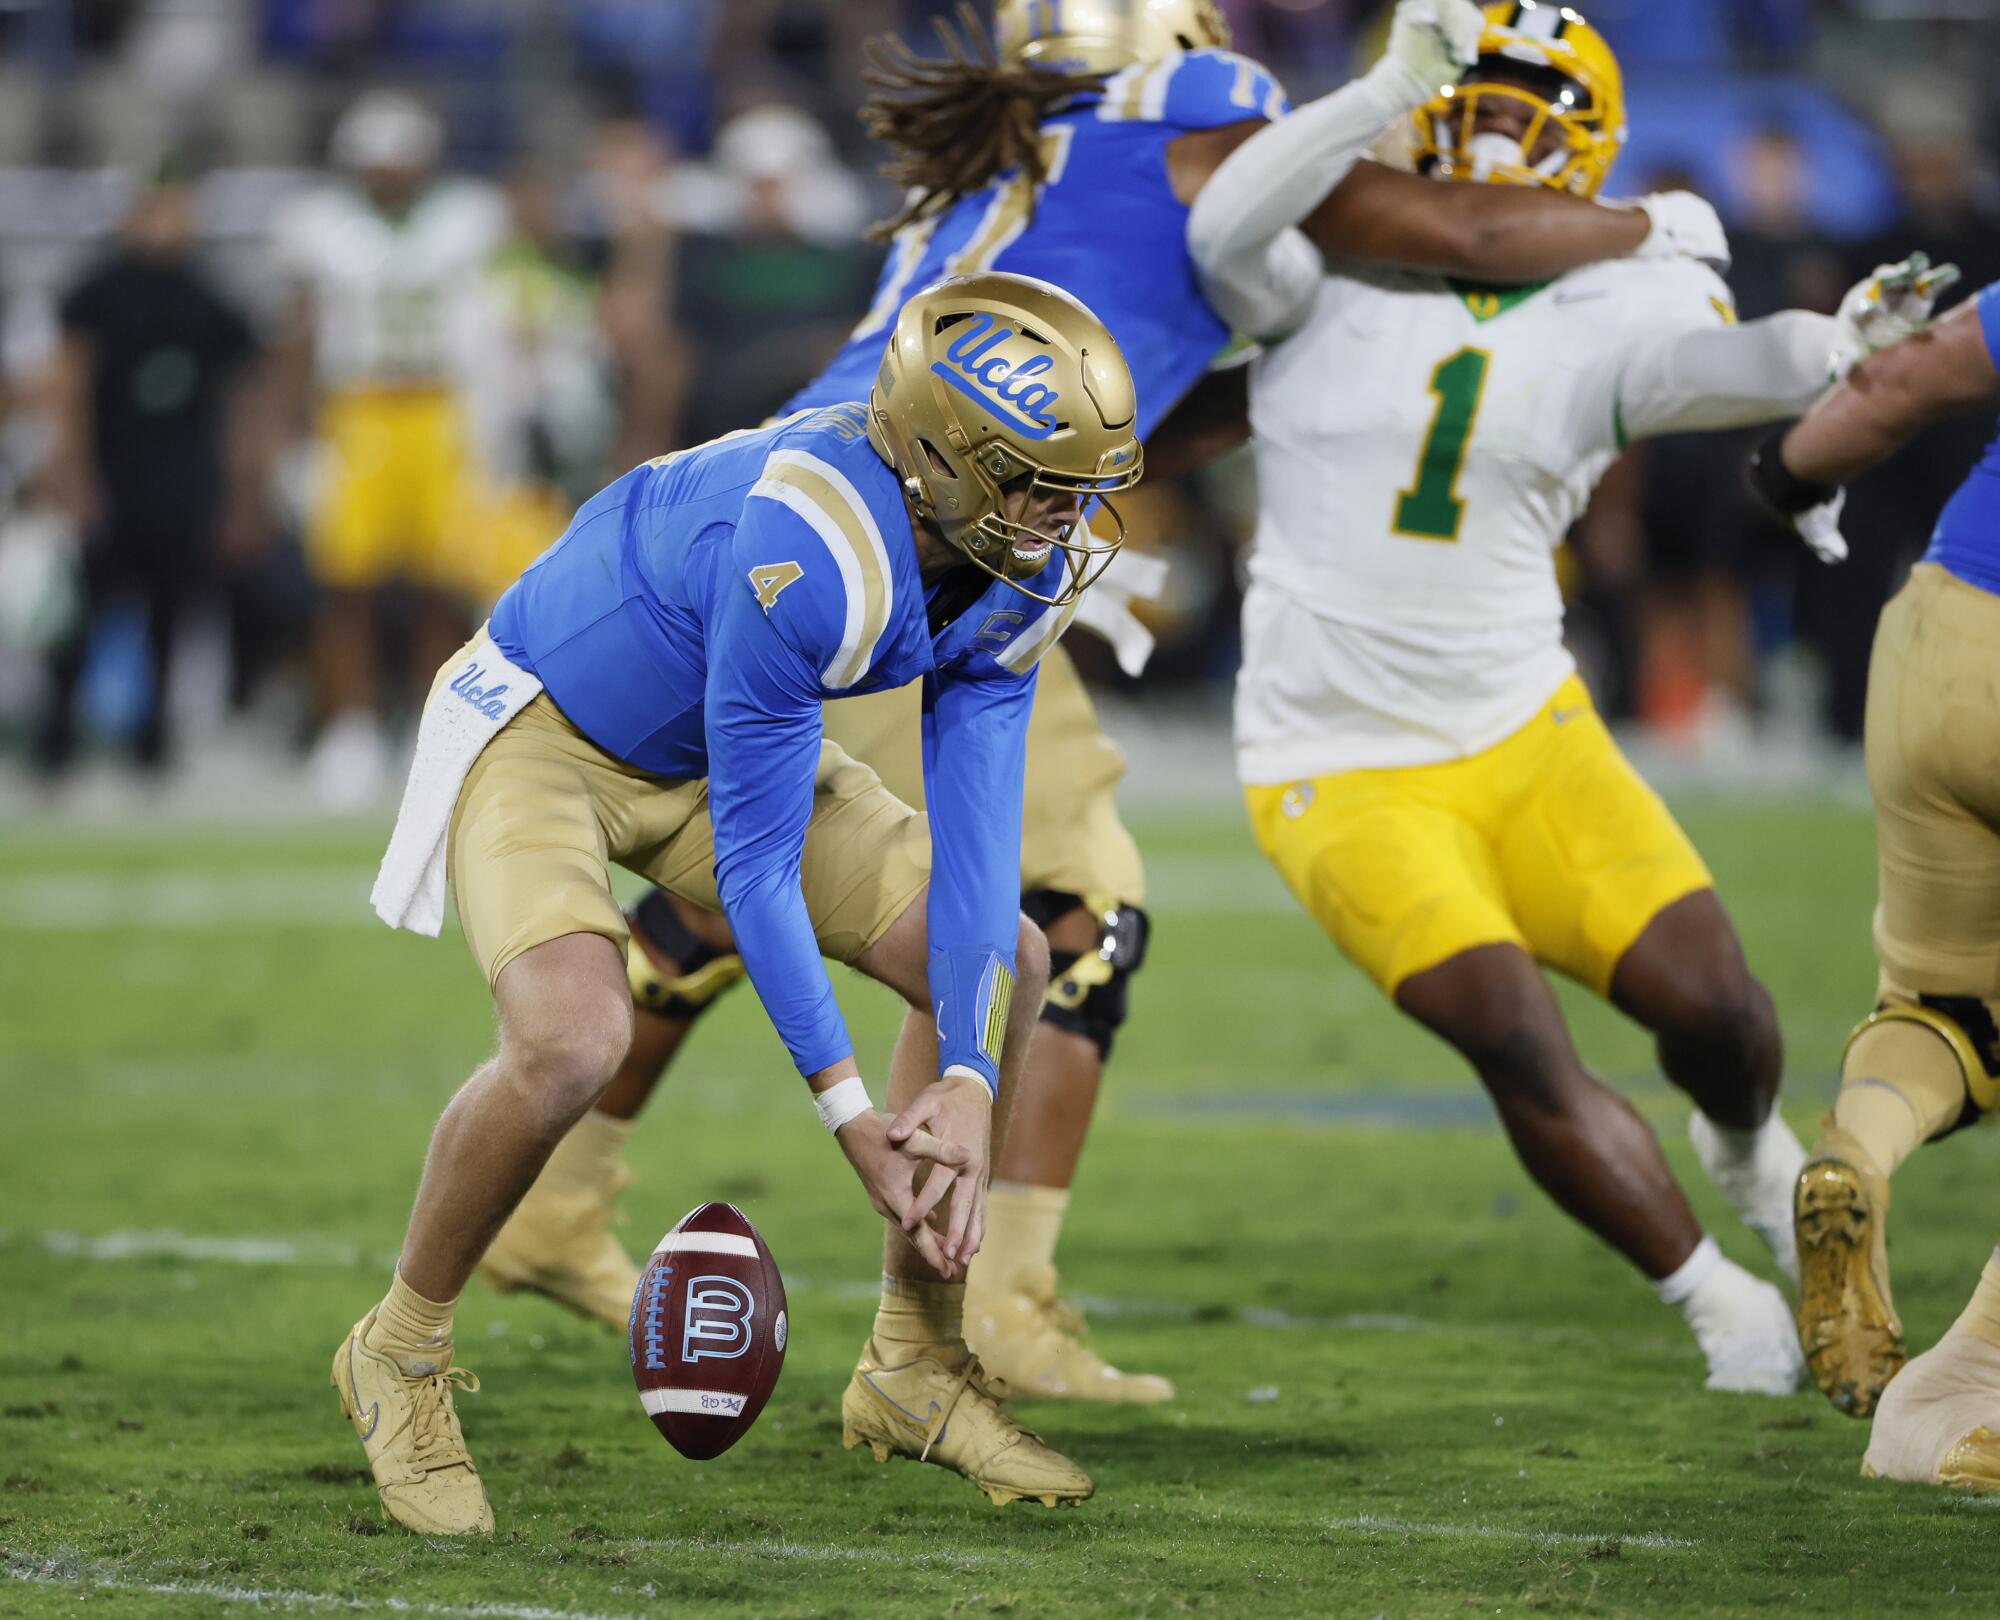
<box><xmin>1194</xmin><ymin>0</ymin><xmax>1944</xmax><ymax>1394</ymax></box>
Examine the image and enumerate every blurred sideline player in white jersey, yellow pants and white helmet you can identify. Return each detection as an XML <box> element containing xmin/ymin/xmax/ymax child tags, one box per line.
<box><xmin>274</xmin><ymin>90</ymin><xmax>506</xmax><ymax>810</ymax></box>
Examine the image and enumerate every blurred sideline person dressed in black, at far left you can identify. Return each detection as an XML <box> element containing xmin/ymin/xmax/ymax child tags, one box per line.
<box><xmin>34</xmin><ymin>160</ymin><xmax>266</xmax><ymax>772</ymax></box>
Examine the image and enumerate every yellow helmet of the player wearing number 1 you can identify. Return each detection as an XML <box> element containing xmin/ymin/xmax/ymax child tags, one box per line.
<box><xmin>1412</xmin><ymin>0</ymin><xmax>1626</xmax><ymax>196</ymax></box>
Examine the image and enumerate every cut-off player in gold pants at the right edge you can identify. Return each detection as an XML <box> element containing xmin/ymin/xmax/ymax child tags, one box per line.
<box><xmin>1752</xmin><ymin>284</ymin><xmax>2000</xmax><ymax>1490</ymax></box>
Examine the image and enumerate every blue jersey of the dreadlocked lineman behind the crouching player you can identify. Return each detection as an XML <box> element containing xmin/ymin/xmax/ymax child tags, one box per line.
<box><xmin>786</xmin><ymin>50</ymin><xmax>1288</xmax><ymax>438</ymax></box>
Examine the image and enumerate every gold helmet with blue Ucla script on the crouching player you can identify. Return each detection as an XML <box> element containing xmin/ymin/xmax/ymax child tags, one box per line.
<box><xmin>868</xmin><ymin>270</ymin><xmax>1142</xmax><ymax>606</ymax></box>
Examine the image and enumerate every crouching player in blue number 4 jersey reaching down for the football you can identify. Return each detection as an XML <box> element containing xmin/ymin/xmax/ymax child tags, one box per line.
<box><xmin>332</xmin><ymin>274</ymin><xmax>1140</xmax><ymax>1534</ymax></box>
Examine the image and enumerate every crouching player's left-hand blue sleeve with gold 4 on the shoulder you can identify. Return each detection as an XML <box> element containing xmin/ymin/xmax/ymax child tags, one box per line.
<box><xmin>704</xmin><ymin>486</ymin><xmax>854</xmax><ymax>1074</ymax></box>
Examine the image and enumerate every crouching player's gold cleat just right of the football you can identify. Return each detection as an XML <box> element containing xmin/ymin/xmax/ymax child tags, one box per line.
<box><xmin>840</xmin><ymin>1338</ymin><xmax>1096</xmax><ymax>1508</ymax></box>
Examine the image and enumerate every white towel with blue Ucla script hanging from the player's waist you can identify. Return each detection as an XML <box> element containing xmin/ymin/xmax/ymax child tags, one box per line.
<box><xmin>368</xmin><ymin>630</ymin><xmax>542</xmax><ymax>938</ymax></box>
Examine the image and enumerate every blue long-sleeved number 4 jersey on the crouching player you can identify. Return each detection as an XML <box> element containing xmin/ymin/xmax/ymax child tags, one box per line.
<box><xmin>492</xmin><ymin>404</ymin><xmax>1068</xmax><ymax>1086</ymax></box>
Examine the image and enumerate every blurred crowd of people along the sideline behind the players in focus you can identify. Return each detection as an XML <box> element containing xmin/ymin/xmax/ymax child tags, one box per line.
<box><xmin>0</xmin><ymin>0</ymin><xmax>2000</xmax><ymax>810</ymax></box>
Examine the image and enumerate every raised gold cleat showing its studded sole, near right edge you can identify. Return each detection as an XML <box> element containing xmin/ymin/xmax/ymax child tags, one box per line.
<box><xmin>1792</xmin><ymin>1120</ymin><xmax>1904</xmax><ymax>1418</ymax></box>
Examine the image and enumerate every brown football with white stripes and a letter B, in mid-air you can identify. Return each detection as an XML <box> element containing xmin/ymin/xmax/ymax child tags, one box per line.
<box><xmin>630</xmin><ymin>1204</ymin><xmax>788</xmax><ymax>1462</ymax></box>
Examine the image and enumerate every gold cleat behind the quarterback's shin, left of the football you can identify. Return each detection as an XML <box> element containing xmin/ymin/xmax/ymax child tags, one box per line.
<box><xmin>480</xmin><ymin>1148</ymin><xmax>640</xmax><ymax>1332</ymax></box>
